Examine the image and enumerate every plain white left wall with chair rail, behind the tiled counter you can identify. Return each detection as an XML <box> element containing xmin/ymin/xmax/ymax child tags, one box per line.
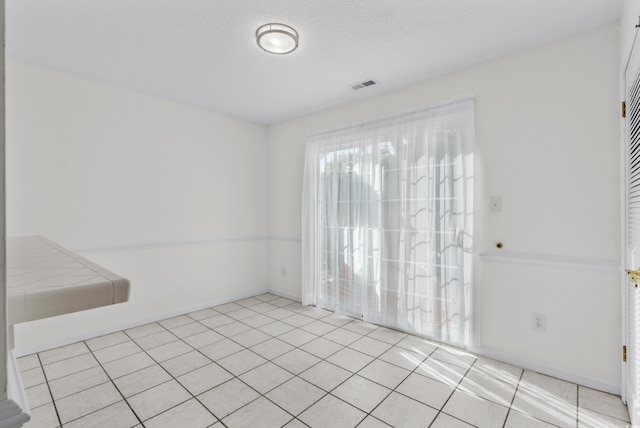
<box><xmin>7</xmin><ymin>61</ymin><xmax>268</xmax><ymax>350</ymax></box>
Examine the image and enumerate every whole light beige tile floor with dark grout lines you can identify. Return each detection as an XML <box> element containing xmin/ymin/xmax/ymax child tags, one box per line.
<box><xmin>18</xmin><ymin>294</ymin><xmax>629</xmax><ymax>428</ymax></box>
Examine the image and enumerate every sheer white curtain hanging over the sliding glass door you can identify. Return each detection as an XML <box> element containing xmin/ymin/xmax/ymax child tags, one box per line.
<box><xmin>302</xmin><ymin>99</ymin><xmax>475</xmax><ymax>345</ymax></box>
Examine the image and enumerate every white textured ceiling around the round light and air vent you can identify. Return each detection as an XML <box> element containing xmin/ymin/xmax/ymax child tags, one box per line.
<box><xmin>6</xmin><ymin>0</ymin><xmax>622</xmax><ymax>124</ymax></box>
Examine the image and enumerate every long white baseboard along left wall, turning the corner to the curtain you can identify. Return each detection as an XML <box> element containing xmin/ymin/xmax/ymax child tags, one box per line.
<box><xmin>12</xmin><ymin>288</ymin><xmax>300</xmax><ymax>358</ymax></box>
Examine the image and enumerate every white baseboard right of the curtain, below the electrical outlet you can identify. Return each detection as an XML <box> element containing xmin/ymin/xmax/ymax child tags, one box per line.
<box><xmin>469</xmin><ymin>346</ymin><xmax>622</xmax><ymax>395</ymax></box>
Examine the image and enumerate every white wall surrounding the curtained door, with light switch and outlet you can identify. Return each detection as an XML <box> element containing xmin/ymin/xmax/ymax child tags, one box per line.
<box><xmin>269</xmin><ymin>24</ymin><xmax>620</xmax><ymax>392</ymax></box>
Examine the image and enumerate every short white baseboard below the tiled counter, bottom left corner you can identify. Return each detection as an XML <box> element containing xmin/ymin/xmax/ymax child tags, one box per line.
<box><xmin>0</xmin><ymin>351</ymin><xmax>31</xmax><ymax>428</ymax></box>
